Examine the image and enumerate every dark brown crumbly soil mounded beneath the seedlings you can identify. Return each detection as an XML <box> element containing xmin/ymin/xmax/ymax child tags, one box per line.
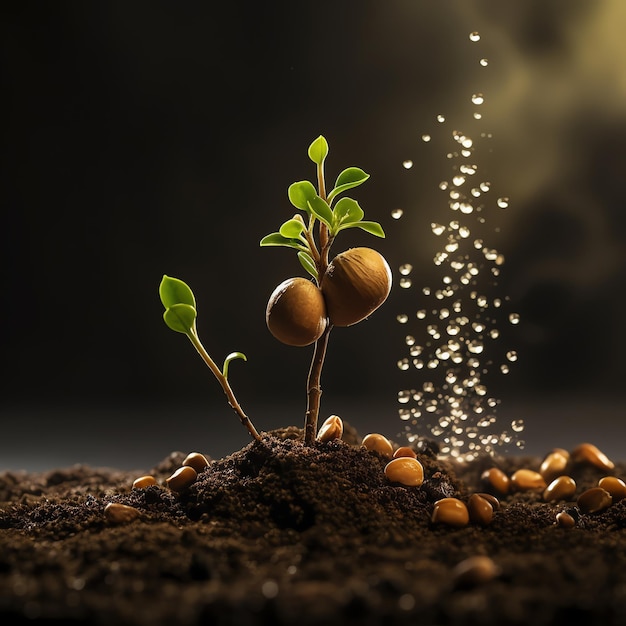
<box><xmin>0</xmin><ymin>431</ymin><xmax>626</xmax><ymax>626</ymax></box>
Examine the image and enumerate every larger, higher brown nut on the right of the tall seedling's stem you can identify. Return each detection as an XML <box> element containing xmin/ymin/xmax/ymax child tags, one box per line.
<box><xmin>321</xmin><ymin>248</ymin><xmax>391</xmax><ymax>326</ymax></box>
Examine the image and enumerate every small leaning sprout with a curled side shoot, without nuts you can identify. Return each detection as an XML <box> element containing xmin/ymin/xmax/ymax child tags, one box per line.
<box><xmin>159</xmin><ymin>276</ymin><xmax>261</xmax><ymax>441</ymax></box>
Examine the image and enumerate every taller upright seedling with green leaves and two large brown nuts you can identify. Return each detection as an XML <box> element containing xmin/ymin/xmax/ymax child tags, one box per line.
<box><xmin>261</xmin><ymin>136</ymin><xmax>391</xmax><ymax>444</ymax></box>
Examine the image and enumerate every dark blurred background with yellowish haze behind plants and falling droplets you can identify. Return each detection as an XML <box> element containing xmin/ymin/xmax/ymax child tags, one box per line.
<box><xmin>0</xmin><ymin>0</ymin><xmax>626</xmax><ymax>469</ymax></box>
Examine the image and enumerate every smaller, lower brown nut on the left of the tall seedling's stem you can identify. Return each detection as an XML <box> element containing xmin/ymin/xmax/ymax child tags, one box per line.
<box><xmin>265</xmin><ymin>277</ymin><xmax>327</xmax><ymax>346</ymax></box>
